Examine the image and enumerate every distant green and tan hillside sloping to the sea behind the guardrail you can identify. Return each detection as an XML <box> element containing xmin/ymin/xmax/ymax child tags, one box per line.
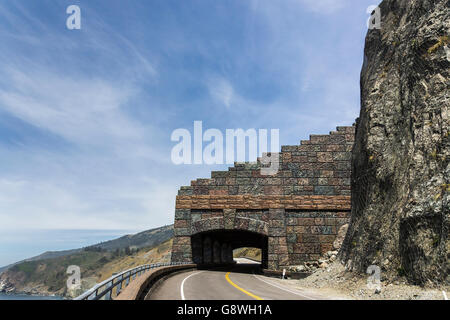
<box><xmin>0</xmin><ymin>226</ymin><xmax>173</xmax><ymax>296</ymax></box>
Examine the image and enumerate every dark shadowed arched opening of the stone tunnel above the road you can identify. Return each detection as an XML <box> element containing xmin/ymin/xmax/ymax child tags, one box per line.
<box><xmin>191</xmin><ymin>230</ymin><xmax>268</xmax><ymax>268</ymax></box>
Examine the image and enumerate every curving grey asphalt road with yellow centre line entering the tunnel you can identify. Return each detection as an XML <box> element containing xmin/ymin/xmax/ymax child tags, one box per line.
<box><xmin>147</xmin><ymin>258</ymin><xmax>323</xmax><ymax>300</ymax></box>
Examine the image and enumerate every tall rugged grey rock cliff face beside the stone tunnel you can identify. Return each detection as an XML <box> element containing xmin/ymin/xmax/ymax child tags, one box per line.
<box><xmin>340</xmin><ymin>0</ymin><xmax>450</xmax><ymax>284</ymax></box>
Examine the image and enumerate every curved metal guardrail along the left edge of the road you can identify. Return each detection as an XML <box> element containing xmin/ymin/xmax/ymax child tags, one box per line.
<box><xmin>73</xmin><ymin>262</ymin><xmax>189</xmax><ymax>300</ymax></box>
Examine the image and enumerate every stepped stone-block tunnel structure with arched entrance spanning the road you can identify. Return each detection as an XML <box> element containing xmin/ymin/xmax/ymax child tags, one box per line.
<box><xmin>171</xmin><ymin>127</ymin><xmax>355</xmax><ymax>270</ymax></box>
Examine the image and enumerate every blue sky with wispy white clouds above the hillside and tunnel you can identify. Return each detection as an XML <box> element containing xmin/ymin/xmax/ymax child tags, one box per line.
<box><xmin>0</xmin><ymin>0</ymin><xmax>380</xmax><ymax>266</ymax></box>
